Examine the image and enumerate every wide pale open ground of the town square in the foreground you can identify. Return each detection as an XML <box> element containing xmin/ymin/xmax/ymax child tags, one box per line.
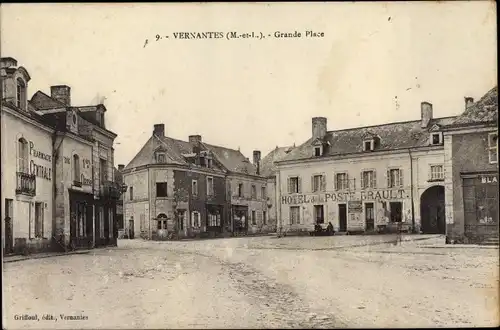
<box><xmin>3</xmin><ymin>235</ymin><xmax>499</xmax><ymax>329</ymax></box>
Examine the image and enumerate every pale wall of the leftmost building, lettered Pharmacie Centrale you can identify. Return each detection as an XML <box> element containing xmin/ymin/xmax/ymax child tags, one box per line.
<box><xmin>1</xmin><ymin>107</ymin><xmax>53</xmax><ymax>248</ymax></box>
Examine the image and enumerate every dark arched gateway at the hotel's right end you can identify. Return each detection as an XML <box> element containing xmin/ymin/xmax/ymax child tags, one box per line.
<box><xmin>420</xmin><ymin>185</ymin><xmax>446</xmax><ymax>234</ymax></box>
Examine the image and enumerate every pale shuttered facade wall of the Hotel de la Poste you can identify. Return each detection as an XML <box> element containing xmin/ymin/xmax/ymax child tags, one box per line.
<box><xmin>277</xmin><ymin>148</ymin><xmax>444</xmax><ymax>231</ymax></box>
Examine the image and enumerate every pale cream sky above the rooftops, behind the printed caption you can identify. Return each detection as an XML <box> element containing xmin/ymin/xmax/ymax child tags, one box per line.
<box><xmin>0</xmin><ymin>1</ymin><xmax>497</xmax><ymax>165</ymax></box>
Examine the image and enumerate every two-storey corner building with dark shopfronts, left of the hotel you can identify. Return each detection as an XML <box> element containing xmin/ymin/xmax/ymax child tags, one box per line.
<box><xmin>123</xmin><ymin>124</ymin><xmax>267</xmax><ymax>239</ymax></box>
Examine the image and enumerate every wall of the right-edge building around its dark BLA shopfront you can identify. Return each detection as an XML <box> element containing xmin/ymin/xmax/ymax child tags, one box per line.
<box><xmin>445</xmin><ymin>129</ymin><xmax>498</xmax><ymax>241</ymax></box>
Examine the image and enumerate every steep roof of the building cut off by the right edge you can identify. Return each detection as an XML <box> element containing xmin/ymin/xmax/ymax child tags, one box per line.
<box><xmin>449</xmin><ymin>86</ymin><xmax>498</xmax><ymax>127</ymax></box>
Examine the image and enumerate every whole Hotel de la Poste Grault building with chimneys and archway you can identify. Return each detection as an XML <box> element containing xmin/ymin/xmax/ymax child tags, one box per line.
<box><xmin>276</xmin><ymin>102</ymin><xmax>454</xmax><ymax>234</ymax></box>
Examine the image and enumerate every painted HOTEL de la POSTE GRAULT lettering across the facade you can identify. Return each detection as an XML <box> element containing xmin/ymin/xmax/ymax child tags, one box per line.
<box><xmin>281</xmin><ymin>189</ymin><xmax>410</xmax><ymax>204</ymax></box>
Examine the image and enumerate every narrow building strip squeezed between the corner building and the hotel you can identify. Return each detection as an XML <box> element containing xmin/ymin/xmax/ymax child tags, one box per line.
<box><xmin>260</xmin><ymin>145</ymin><xmax>295</xmax><ymax>232</ymax></box>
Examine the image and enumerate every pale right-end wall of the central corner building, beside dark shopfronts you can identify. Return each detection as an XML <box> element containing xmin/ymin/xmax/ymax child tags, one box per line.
<box><xmin>227</xmin><ymin>175</ymin><xmax>273</xmax><ymax>233</ymax></box>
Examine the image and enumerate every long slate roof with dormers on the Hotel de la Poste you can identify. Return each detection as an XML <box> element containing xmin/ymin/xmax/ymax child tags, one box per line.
<box><xmin>282</xmin><ymin>117</ymin><xmax>455</xmax><ymax>161</ymax></box>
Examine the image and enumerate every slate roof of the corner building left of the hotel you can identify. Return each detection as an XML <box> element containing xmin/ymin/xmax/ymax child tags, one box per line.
<box><xmin>125</xmin><ymin>135</ymin><xmax>257</xmax><ymax>175</ymax></box>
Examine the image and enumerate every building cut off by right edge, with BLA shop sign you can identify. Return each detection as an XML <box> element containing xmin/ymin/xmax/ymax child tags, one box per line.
<box><xmin>444</xmin><ymin>86</ymin><xmax>499</xmax><ymax>243</ymax></box>
